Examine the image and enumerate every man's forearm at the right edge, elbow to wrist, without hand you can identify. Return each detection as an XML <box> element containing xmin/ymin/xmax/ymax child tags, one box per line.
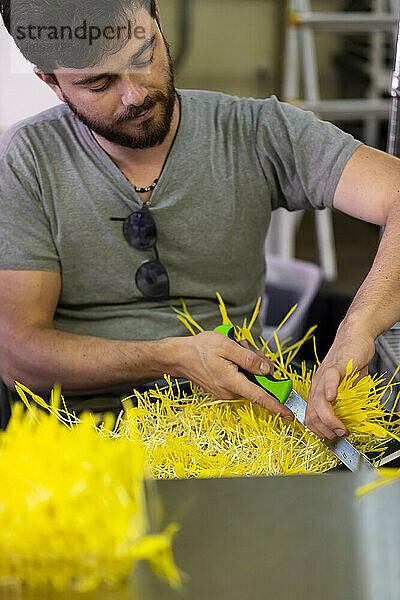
<box><xmin>342</xmin><ymin>201</ymin><xmax>400</xmax><ymax>338</ymax></box>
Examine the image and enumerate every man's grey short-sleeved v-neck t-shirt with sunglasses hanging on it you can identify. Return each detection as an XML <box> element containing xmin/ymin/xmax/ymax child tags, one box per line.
<box><xmin>0</xmin><ymin>90</ymin><xmax>360</xmax><ymax>340</ymax></box>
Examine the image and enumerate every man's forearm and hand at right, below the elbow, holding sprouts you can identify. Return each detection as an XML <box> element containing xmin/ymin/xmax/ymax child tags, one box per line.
<box><xmin>305</xmin><ymin>206</ymin><xmax>400</xmax><ymax>439</ymax></box>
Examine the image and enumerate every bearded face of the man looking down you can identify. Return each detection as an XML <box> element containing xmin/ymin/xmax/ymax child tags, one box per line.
<box><xmin>51</xmin><ymin>9</ymin><xmax>176</xmax><ymax>149</ymax></box>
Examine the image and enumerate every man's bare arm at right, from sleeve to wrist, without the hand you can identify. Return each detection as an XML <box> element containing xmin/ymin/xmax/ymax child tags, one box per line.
<box><xmin>334</xmin><ymin>146</ymin><xmax>400</xmax><ymax>338</ymax></box>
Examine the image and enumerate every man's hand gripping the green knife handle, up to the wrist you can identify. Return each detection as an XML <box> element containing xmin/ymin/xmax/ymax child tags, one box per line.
<box><xmin>171</xmin><ymin>331</ymin><xmax>294</xmax><ymax>421</ymax></box>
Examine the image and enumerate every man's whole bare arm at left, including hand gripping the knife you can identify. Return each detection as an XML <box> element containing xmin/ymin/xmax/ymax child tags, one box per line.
<box><xmin>0</xmin><ymin>271</ymin><xmax>293</xmax><ymax>419</ymax></box>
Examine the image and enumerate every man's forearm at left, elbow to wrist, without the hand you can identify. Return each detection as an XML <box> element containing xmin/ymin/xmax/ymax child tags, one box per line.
<box><xmin>2</xmin><ymin>328</ymin><xmax>183</xmax><ymax>395</ymax></box>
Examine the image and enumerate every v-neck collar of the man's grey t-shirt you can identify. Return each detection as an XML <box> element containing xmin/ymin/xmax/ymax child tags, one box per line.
<box><xmin>76</xmin><ymin>90</ymin><xmax>186</xmax><ymax>207</ymax></box>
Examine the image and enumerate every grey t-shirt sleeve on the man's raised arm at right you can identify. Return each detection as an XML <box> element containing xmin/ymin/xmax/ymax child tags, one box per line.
<box><xmin>256</xmin><ymin>97</ymin><xmax>361</xmax><ymax>210</ymax></box>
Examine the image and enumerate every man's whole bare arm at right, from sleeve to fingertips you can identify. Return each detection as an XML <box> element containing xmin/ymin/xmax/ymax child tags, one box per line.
<box><xmin>306</xmin><ymin>146</ymin><xmax>400</xmax><ymax>439</ymax></box>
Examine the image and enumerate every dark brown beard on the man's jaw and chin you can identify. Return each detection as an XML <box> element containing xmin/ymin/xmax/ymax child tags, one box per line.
<box><xmin>63</xmin><ymin>36</ymin><xmax>176</xmax><ymax>150</ymax></box>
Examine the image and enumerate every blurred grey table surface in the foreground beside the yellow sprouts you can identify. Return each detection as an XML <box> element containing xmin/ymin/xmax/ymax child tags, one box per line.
<box><xmin>5</xmin><ymin>472</ymin><xmax>400</xmax><ymax>600</ymax></box>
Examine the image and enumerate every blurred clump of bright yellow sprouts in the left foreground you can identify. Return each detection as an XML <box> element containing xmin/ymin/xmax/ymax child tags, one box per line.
<box><xmin>0</xmin><ymin>384</ymin><xmax>180</xmax><ymax>596</ymax></box>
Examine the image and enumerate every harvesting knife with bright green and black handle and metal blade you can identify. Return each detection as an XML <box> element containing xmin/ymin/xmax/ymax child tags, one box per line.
<box><xmin>214</xmin><ymin>325</ymin><xmax>375</xmax><ymax>471</ymax></box>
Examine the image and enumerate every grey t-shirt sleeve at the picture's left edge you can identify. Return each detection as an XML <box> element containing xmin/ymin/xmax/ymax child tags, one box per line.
<box><xmin>0</xmin><ymin>138</ymin><xmax>60</xmax><ymax>272</ymax></box>
